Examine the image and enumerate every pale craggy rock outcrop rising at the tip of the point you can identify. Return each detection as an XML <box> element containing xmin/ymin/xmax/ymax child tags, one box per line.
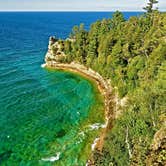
<box><xmin>45</xmin><ymin>36</ymin><xmax>66</xmax><ymax>63</ymax></box>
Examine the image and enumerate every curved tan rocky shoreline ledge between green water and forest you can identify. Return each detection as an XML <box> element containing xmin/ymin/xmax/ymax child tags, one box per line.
<box><xmin>41</xmin><ymin>61</ymin><xmax>113</xmax><ymax>153</ymax></box>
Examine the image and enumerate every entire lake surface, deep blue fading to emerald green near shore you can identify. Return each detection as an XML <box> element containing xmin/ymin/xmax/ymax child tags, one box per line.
<box><xmin>0</xmin><ymin>12</ymin><xmax>143</xmax><ymax>166</ymax></box>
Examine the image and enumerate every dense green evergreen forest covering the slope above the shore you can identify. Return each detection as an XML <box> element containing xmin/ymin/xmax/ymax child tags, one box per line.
<box><xmin>51</xmin><ymin>1</ymin><xmax>166</xmax><ymax>166</ymax></box>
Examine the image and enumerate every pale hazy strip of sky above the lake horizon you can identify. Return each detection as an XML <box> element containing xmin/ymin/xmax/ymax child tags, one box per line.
<box><xmin>0</xmin><ymin>0</ymin><xmax>166</xmax><ymax>11</ymax></box>
